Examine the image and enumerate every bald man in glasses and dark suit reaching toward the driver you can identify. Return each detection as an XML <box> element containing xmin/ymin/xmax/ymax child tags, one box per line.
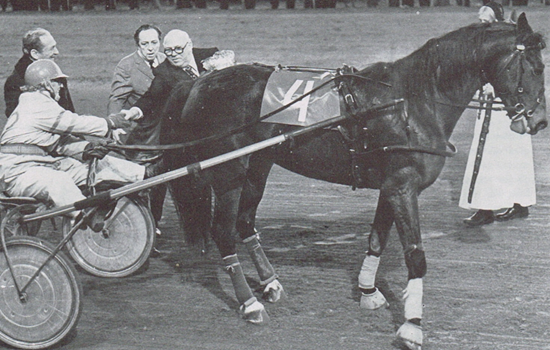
<box><xmin>121</xmin><ymin>29</ymin><xmax>218</xmax><ymax>243</ymax></box>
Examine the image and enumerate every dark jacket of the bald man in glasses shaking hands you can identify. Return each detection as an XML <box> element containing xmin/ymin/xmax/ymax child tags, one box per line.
<box><xmin>126</xmin><ymin>47</ymin><xmax>218</xmax><ymax>150</ymax></box>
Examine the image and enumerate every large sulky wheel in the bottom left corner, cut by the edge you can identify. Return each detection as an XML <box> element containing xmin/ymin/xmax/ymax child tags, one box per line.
<box><xmin>0</xmin><ymin>237</ymin><xmax>82</xmax><ymax>349</ymax></box>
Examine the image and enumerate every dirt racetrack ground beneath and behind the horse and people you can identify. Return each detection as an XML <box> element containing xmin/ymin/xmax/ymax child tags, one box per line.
<box><xmin>0</xmin><ymin>3</ymin><xmax>550</xmax><ymax>350</ymax></box>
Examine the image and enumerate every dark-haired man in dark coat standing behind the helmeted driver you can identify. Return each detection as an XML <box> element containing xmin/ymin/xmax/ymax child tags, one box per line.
<box><xmin>4</xmin><ymin>28</ymin><xmax>74</xmax><ymax>118</ymax></box>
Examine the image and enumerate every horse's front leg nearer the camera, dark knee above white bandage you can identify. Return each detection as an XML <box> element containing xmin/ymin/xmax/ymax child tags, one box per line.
<box><xmin>388</xmin><ymin>173</ymin><xmax>427</xmax><ymax>350</ymax></box>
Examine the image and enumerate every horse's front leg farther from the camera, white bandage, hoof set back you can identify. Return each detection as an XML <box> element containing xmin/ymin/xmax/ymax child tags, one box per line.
<box><xmin>359</xmin><ymin>194</ymin><xmax>393</xmax><ymax>310</ymax></box>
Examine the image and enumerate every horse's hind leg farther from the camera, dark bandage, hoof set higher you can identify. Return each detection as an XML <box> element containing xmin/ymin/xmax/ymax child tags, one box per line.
<box><xmin>237</xmin><ymin>153</ymin><xmax>283</xmax><ymax>303</ymax></box>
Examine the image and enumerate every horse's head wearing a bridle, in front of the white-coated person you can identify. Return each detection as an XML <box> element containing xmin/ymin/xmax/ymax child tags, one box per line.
<box><xmin>484</xmin><ymin>13</ymin><xmax>548</xmax><ymax>135</ymax></box>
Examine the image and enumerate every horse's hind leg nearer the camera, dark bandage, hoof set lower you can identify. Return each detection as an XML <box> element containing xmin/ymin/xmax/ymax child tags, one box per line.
<box><xmin>212</xmin><ymin>163</ymin><xmax>269</xmax><ymax>324</ymax></box>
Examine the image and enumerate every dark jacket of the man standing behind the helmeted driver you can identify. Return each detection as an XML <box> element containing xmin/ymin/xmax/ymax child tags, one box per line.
<box><xmin>4</xmin><ymin>55</ymin><xmax>74</xmax><ymax>118</ymax></box>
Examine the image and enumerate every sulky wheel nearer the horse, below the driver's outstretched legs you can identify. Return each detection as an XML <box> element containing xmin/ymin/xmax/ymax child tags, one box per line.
<box><xmin>63</xmin><ymin>197</ymin><xmax>155</xmax><ymax>277</ymax></box>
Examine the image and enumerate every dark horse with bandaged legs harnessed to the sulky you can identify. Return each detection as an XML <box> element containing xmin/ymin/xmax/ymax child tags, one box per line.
<box><xmin>162</xmin><ymin>14</ymin><xmax>547</xmax><ymax>349</ymax></box>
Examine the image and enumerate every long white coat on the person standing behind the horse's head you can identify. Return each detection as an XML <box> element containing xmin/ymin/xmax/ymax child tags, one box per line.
<box><xmin>459</xmin><ymin>101</ymin><xmax>536</xmax><ymax>210</ymax></box>
